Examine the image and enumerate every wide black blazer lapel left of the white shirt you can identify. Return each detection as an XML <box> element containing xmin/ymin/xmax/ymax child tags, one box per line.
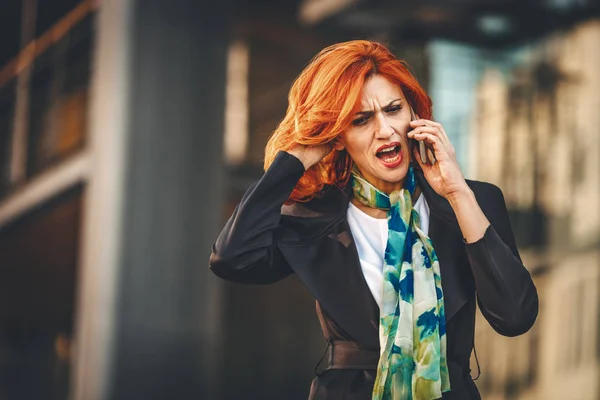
<box><xmin>279</xmin><ymin>187</ymin><xmax>379</xmax><ymax>349</ymax></box>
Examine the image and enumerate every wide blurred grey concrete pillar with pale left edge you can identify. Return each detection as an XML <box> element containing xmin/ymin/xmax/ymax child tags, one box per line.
<box><xmin>71</xmin><ymin>0</ymin><xmax>233</xmax><ymax>400</ymax></box>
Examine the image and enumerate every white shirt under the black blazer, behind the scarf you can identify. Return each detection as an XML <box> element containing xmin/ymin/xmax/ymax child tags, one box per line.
<box><xmin>347</xmin><ymin>193</ymin><xmax>429</xmax><ymax>307</ymax></box>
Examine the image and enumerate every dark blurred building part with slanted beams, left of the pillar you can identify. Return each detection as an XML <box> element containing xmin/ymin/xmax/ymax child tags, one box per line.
<box><xmin>0</xmin><ymin>0</ymin><xmax>95</xmax><ymax>399</ymax></box>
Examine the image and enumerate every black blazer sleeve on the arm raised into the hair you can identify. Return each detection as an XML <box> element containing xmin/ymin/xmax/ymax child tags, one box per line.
<box><xmin>209</xmin><ymin>151</ymin><xmax>304</xmax><ymax>284</ymax></box>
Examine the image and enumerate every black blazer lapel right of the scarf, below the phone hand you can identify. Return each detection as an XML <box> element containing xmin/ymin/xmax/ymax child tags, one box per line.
<box><xmin>415</xmin><ymin>169</ymin><xmax>470</xmax><ymax>321</ymax></box>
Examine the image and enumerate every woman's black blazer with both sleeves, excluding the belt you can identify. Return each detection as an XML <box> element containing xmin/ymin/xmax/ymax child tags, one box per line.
<box><xmin>210</xmin><ymin>152</ymin><xmax>538</xmax><ymax>400</ymax></box>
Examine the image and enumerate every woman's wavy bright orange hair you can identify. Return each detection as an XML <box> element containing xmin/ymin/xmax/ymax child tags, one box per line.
<box><xmin>264</xmin><ymin>40</ymin><xmax>431</xmax><ymax>202</ymax></box>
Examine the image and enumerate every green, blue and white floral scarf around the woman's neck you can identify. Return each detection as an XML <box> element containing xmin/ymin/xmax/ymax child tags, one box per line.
<box><xmin>352</xmin><ymin>166</ymin><xmax>450</xmax><ymax>400</ymax></box>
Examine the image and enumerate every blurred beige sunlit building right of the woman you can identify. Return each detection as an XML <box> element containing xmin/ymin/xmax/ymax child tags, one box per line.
<box><xmin>470</xmin><ymin>19</ymin><xmax>600</xmax><ymax>400</ymax></box>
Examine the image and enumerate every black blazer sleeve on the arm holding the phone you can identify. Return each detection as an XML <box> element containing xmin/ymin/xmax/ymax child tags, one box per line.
<box><xmin>466</xmin><ymin>184</ymin><xmax>538</xmax><ymax>336</ymax></box>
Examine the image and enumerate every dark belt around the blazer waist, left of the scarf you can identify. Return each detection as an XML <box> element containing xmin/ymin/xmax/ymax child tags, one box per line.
<box><xmin>315</xmin><ymin>340</ymin><xmax>379</xmax><ymax>375</ymax></box>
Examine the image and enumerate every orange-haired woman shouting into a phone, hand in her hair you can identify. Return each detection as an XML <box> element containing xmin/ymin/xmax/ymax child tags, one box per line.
<box><xmin>210</xmin><ymin>40</ymin><xmax>538</xmax><ymax>400</ymax></box>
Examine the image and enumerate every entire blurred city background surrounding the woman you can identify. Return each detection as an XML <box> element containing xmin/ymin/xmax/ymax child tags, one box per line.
<box><xmin>0</xmin><ymin>0</ymin><xmax>600</xmax><ymax>400</ymax></box>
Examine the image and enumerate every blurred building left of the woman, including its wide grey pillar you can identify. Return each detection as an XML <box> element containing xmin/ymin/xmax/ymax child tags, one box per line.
<box><xmin>0</xmin><ymin>0</ymin><xmax>231</xmax><ymax>400</ymax></box>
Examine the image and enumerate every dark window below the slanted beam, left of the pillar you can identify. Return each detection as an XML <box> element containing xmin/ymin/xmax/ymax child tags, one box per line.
<box><xmin>0</xmin><ymin>187</ymin><xmax>82</xmax><ymax>400</ymax></box>
